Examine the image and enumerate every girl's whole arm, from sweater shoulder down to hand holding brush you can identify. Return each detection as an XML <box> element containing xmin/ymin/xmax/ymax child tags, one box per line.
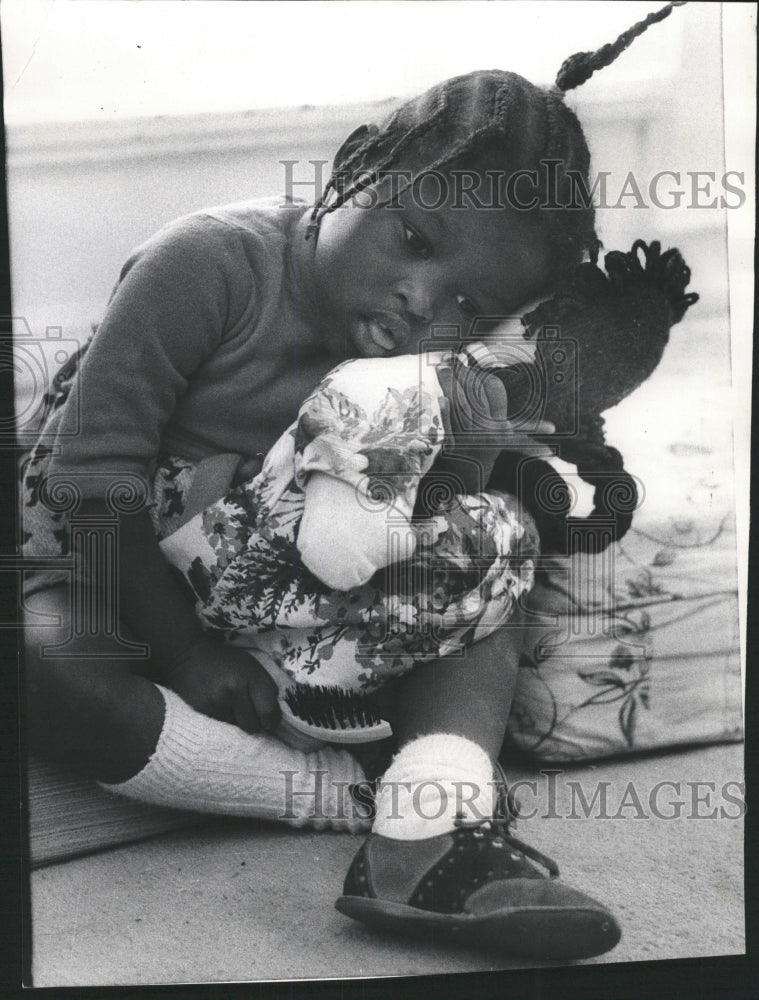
<box><xmin>51</xmin><ymin>219</ymin><xmax>278</xmax><ymax>731</ymax></box>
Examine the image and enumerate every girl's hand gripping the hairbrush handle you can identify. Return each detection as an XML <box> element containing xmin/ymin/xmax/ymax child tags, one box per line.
<box><xmin>163</xmin><ymin>636</ymin><xmax>280</xmax><ymax>733</ymax></box>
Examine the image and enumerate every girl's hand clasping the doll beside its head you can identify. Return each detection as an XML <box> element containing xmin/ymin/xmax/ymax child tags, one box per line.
<box><xmin>436</xmin><ymin>358</ymin><xmax>556</xmax><ymax>493</ymax></box>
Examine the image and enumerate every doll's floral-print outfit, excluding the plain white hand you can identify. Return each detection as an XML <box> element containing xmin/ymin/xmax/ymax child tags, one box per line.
<box><xmin>161</xmin><ymin>358</ymin><xmax>538</xmax><ymax>690</ymax></box>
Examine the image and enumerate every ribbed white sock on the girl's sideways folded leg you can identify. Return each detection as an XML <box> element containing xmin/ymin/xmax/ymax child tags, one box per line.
<box><xmin>102</xmin><ymin>687</ymin><xmax>369</xmax><ymax>832</ymax></box>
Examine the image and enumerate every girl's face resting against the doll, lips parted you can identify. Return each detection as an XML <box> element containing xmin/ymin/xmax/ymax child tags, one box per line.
<box><xmin>302</xmin><ymin>177</ymin><xmax>549</xmax><ymax>358</ymax></box>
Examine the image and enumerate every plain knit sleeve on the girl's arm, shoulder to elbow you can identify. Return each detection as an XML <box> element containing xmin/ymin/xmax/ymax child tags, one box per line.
<box><xmin>51</xmin><ymin>214</ymin><xmax>253</xmax><ymax>497</ymax></box>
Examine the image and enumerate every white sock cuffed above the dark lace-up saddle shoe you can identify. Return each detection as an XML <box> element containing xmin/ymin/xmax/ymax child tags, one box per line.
<box><xmin>372</xmin><ymin>733</ymin><xmax>495</xmax><ymax>840</ymax></box>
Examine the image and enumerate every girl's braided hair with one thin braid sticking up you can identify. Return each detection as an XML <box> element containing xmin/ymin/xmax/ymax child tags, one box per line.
<box><xmin>306</xmin><ymin>0</ymin><xmax>684</xmax><ymax>279</ymax></box>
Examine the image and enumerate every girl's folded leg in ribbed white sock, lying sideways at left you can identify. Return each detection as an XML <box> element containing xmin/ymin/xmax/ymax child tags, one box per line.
<box><xmin>26</xmin><ymin>586</ymin><xmax>368</xmax><ymax>831</ymax></box>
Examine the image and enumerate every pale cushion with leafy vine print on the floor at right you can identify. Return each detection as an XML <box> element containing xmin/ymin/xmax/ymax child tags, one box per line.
<box><xmin>508</xmin><ymin>518</ymin><xmax>743</xmax><ymax>761</ymax></box>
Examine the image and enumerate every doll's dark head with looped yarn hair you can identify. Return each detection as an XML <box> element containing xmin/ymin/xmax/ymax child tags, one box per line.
<box><xmin>491</xmin><ymin>240</ymin><xmax>698</xmax><ymax>554</ymax></box>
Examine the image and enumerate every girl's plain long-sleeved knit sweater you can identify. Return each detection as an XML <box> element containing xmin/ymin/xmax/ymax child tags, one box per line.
<box><xmin>44</xmin><ymin>198</ymin><xmax>335</xmax><ymax>496</ymax></box>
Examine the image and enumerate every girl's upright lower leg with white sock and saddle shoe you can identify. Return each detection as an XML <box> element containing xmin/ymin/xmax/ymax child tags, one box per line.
<box><xmin>336</xmin><ymin>619</ymin><xmax>621</xmax><ymax>959</ymax></box>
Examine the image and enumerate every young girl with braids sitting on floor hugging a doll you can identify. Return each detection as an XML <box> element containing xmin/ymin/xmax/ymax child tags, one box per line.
<box><xmin>25</xmin><ymin>5</ymin><xmax>688</xmax><ymax>957</ymax></box>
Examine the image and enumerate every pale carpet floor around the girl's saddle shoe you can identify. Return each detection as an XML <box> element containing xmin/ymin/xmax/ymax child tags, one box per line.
<box><xmin>30</xmin><ymin>744</ymin><xmax>744</xmax><ymax>987</ymax></box>
